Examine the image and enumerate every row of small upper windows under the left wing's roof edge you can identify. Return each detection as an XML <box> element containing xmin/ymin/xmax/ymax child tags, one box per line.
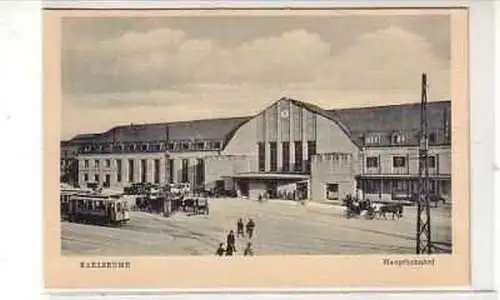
<box><xmin>81</xmin><ymin>141</ymin><xmax>222</xmax><ymax>153</ymax></box>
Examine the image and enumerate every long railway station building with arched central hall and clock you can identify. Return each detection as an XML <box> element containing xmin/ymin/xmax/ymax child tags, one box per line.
<box><xmin>61</xmin><ymin>98</ymin><xmax>451</xmax><ymax>201</ymax></box>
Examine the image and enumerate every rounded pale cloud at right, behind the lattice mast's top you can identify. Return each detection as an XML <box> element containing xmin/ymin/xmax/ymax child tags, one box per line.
<box><xmin>320</xmin><ymin>27</ymin><xmax>450</xmax><ymax>98</ymax></box>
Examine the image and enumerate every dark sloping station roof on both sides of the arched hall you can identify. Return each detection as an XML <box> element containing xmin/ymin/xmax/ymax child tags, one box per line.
<box><xmin>65</xmin><ymin>98</ymin><xmax>451</xmax><ymax>146</ymax></box>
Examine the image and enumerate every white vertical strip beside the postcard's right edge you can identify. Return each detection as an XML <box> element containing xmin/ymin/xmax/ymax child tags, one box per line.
<box><xmin>469</xmin><ymin>0</ymin><xmax>496</xmax><ymax>290</ymax></box>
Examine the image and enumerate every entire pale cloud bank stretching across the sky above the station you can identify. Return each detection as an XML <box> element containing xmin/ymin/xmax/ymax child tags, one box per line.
<box><xmin>63</xmin><ymin>26</ymin><xmax>450</xmax><ymax>136</ymax></box>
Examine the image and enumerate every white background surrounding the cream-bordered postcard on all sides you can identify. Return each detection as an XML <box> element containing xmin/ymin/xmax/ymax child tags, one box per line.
<box><xmin>0</xmin><ymin>0</ymin><xmax>494</xmax><ymax>300</ymax></box>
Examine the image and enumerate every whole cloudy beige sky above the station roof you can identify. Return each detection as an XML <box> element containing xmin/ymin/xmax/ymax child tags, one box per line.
<box><xmin>61</xmin><ymin>15</ymin><xmax>451</xmax><ymax>139</ymax></box>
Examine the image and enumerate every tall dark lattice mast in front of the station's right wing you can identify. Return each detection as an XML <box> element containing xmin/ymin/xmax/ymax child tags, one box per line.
<box><xmin>417</xmin><ymin>73</ymin><xmax>432</xmax><ymax>254</ymax></box>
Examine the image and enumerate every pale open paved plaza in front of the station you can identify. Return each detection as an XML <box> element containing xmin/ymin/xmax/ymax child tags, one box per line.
<box><xmin>62</xmin><ymin>199</ymin><xmax>451</xmax><ymax>256</ymax></box>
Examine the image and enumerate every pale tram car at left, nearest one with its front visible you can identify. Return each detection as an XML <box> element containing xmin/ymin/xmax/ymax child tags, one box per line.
<box><xmin>66</xmin><ymin>193</ymin><xmax>130</xmax><ymax>225</ymax></box>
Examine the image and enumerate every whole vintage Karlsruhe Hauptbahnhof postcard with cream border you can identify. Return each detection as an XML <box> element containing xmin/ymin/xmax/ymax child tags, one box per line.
<box><xmin>44</xmin><ymin>8</ymin><xmax>470</xmax><ymax>289</ymax></box>
